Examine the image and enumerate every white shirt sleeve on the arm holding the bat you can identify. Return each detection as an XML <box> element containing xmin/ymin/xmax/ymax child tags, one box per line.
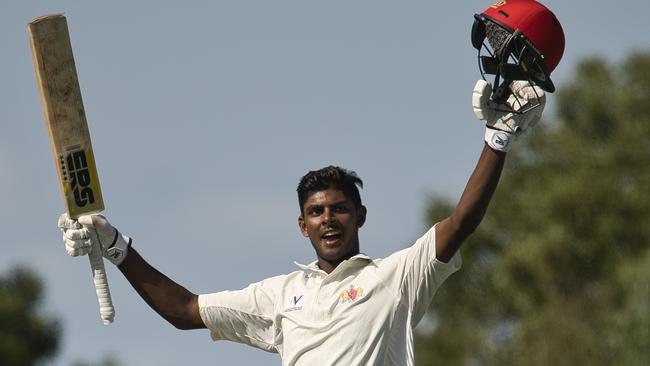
<box><xmin>199</xmin><ymin>279</ymin><xmax>279</xmax><ymax>352</ymax></box>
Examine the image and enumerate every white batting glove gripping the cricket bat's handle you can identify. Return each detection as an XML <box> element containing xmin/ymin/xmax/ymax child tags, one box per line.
<box><xmin>58</xmin><ymin>214</ymin><xmax>131</xmax><ymax>266</ymax></box>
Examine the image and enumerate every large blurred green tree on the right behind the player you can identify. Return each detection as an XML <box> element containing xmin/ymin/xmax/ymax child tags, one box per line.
<box><xmin>416</xmin><ymin>53</ymin><xmax>650</xmax><ymax>365</ymax></box>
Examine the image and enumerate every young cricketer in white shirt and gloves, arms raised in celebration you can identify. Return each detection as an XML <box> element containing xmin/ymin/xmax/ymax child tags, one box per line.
<box><xmin>59</xmin><ymin>76</ymin><xmax>544</xmax><ymax>365</ymax></box>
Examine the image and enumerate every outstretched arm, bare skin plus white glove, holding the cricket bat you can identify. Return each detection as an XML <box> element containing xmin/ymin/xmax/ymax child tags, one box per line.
<box><xmin>59</xmin><ymin>214</ymin><xmax>205</xmax><ymax>329</ymax></box>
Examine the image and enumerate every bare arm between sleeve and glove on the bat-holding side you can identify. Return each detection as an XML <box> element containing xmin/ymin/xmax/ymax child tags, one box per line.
<box><xmin>118</xmin><ymin>247</ymin><xmax>205</xmax><ymax>329</ymax></box>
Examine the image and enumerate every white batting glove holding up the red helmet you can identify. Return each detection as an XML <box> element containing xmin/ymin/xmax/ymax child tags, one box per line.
<box><xmin>472</xmin><ymin>79</ymin><xmax>546</xmax><ymax>151</ymax></box>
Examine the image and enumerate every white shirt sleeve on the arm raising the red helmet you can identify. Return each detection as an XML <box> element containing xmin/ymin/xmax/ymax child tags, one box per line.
<box><xmin>396</xmin><ymin>226</ymin><xmax>462</xmax><ymax>326</ymax></box>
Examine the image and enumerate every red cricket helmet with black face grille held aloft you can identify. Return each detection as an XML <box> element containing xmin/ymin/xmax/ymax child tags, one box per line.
<box><xmin>472</xmin><ymin>0</ymin><xmax>564</xmax><ymax>101</ymax></box>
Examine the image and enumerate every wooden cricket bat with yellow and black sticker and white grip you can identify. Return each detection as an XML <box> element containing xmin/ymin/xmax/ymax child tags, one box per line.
<box><xmin>27</xmin><ymin>14</ymin><xmax>115</xmax><ymax>324</ymax></box>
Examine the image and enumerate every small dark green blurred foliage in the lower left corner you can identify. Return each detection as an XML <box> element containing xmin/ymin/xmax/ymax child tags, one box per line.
<box><xmin>0</xmin><ymin>268</ymin><xmax>59</xmax><ymax>366</ymax></box>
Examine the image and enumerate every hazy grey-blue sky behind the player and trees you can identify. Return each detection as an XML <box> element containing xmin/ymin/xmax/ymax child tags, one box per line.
<box><xmin>0</xmin><ymin>0</ymin><xmax>650</xmax><ymax>365</ymax></box>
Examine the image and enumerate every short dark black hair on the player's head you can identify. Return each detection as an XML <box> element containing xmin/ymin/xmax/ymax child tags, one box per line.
<box><xmin>297</xmin><ymin>165</ymin><xmax>363</xmax><ymax>214</ymax></box>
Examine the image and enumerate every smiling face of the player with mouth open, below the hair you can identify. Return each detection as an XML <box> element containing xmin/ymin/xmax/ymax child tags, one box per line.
<box><xmin>298</xmin><ymin>188</ymin><xmax>366</xmax><ymax>273</ymax></box>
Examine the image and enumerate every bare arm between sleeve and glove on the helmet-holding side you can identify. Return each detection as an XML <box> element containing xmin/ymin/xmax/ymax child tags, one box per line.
<box><xmin>436</xmin><ymin>145</ymin><xmax>506</xmax><ymax>262</ymax></box>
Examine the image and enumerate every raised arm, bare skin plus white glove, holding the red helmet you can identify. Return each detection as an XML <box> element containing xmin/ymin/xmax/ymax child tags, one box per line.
<box><xmin>436</xmin><ymin>80</ymin><xmax>546</xmax><ymax>262</ymax></box>
